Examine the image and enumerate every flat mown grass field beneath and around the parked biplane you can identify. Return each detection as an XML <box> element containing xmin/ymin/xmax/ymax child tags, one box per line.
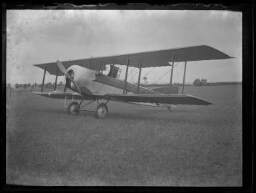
<box><xmin>6</xmin><ymin>86</ymin><xmax>242</xmax><ymax>186</ymax></box>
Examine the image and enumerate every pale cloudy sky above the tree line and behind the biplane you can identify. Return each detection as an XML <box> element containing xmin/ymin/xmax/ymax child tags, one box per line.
<box><xmin>6</xmin><ymin>10</ymin><xmax>242</xmax><ymax>85</ymax></box>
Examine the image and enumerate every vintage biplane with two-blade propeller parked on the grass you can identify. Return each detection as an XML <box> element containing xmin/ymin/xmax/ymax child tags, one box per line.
<box><xmin>33</xmin><ymin>45</ymin><xmax>232</xmax><ymax>118</ymax></box>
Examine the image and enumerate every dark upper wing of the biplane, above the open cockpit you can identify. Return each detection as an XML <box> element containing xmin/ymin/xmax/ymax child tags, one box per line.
<box><xmin>35</xmin><ymin>45</ymin><xmax>231</xmax><ymax>76</ymax></box>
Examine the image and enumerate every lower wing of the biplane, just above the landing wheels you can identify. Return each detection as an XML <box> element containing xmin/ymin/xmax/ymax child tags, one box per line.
<box><xmin>33</xmin><ymin>91</ymin><xmax>212</xmax><ymax>106</ymax></box>
